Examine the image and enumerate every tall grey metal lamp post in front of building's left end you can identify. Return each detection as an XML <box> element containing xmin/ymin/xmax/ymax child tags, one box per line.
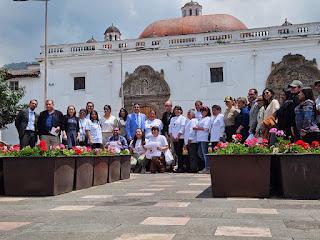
<box><xmin>13</xmin><ymin>0</ymin><xmax>49</xmax><ymax>105</ymax></box>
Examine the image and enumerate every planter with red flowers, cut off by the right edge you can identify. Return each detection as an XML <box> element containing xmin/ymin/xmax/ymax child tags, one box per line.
<box><xmin>273</xmin><ymin>129</ymin><xmax>320</xmax><ymax>199</ymax></box>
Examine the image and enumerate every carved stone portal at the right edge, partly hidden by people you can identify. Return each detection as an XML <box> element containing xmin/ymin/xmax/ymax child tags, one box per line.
<box><xmin>266</xmin><ymin>54</ymin><xmax>320</xmax><ymax>99</ymax></box>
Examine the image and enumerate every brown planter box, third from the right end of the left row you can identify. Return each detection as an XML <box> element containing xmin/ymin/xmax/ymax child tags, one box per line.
<box><xmin>93</xmin><ymin>156</ymin><xmax>109</xmax><ymax>186</ymax></box>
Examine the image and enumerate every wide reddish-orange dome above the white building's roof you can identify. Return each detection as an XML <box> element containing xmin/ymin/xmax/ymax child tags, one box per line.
<box><xmin>140</xmin><ymin>14</ymin><xmax>247</xmax><ymax>38</ymax></box>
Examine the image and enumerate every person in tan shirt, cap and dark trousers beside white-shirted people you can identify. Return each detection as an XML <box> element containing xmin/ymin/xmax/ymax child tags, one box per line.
<box><xmin>223</xmin><ymin>96</ymin><xmax>239</xmax><ymax>142</ymax></box>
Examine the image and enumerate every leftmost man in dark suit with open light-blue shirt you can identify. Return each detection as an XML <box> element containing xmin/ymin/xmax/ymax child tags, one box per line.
<box><xmin>15</xmin><ymin>99</ymin><xmax>39</xmax><ymax>149</ymax></box>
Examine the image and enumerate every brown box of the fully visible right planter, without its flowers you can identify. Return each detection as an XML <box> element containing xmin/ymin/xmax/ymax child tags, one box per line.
<box><xmin>208</xmin><ymin>154</ymin><xmax>271</xmax><ymax>198</ymax></box>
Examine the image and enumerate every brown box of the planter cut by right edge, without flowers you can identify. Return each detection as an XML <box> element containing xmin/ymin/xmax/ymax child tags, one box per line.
<box><xmin>278</xmin><ymin>154</ymin><xmax>320</xmax><ymax>199</ymax></box>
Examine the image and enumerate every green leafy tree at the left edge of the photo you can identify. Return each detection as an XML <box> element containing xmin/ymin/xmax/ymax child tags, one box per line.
<box><xmin>0</xmin><ymin>69</ymin><xmax>25</xmax><ymax>129</ymax></box>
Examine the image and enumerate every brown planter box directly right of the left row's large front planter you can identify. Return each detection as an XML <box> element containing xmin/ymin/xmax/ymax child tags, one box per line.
<box><xmin>73</xmin><ymin>156</ymin><xmax>94</xmax><ymax>190</ymax></box>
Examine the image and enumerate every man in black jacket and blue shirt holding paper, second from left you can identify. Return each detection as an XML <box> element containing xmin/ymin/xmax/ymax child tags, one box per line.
<box><xmin>38</xmin><ymin>100</ymin><xmax>64</xmax><ymax>147</ymax></box>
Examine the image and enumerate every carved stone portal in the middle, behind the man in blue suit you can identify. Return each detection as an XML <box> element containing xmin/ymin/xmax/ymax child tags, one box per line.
<box><xmin>123</xmin><ymin>65</ymin><xmax>170</xmax><ymax>117</ymax></box>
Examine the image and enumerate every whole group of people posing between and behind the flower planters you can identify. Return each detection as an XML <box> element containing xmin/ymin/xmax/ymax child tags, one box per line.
<box><xmin>15</xmin><ymin>80</ymin><xmax>320</xmax><ymax>173</ymax></box>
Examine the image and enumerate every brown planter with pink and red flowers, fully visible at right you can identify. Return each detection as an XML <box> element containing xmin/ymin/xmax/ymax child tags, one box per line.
<box><xmin>208</xmin><ymin>134</ymin><xmax>271</xmax><ymax>198</ymax></box>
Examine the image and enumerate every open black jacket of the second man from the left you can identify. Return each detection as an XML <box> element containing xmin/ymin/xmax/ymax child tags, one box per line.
<box><xmin>38</xmin><ymin>110</ymin><xmax>64</xmax><ymax>135</ymax></box>
